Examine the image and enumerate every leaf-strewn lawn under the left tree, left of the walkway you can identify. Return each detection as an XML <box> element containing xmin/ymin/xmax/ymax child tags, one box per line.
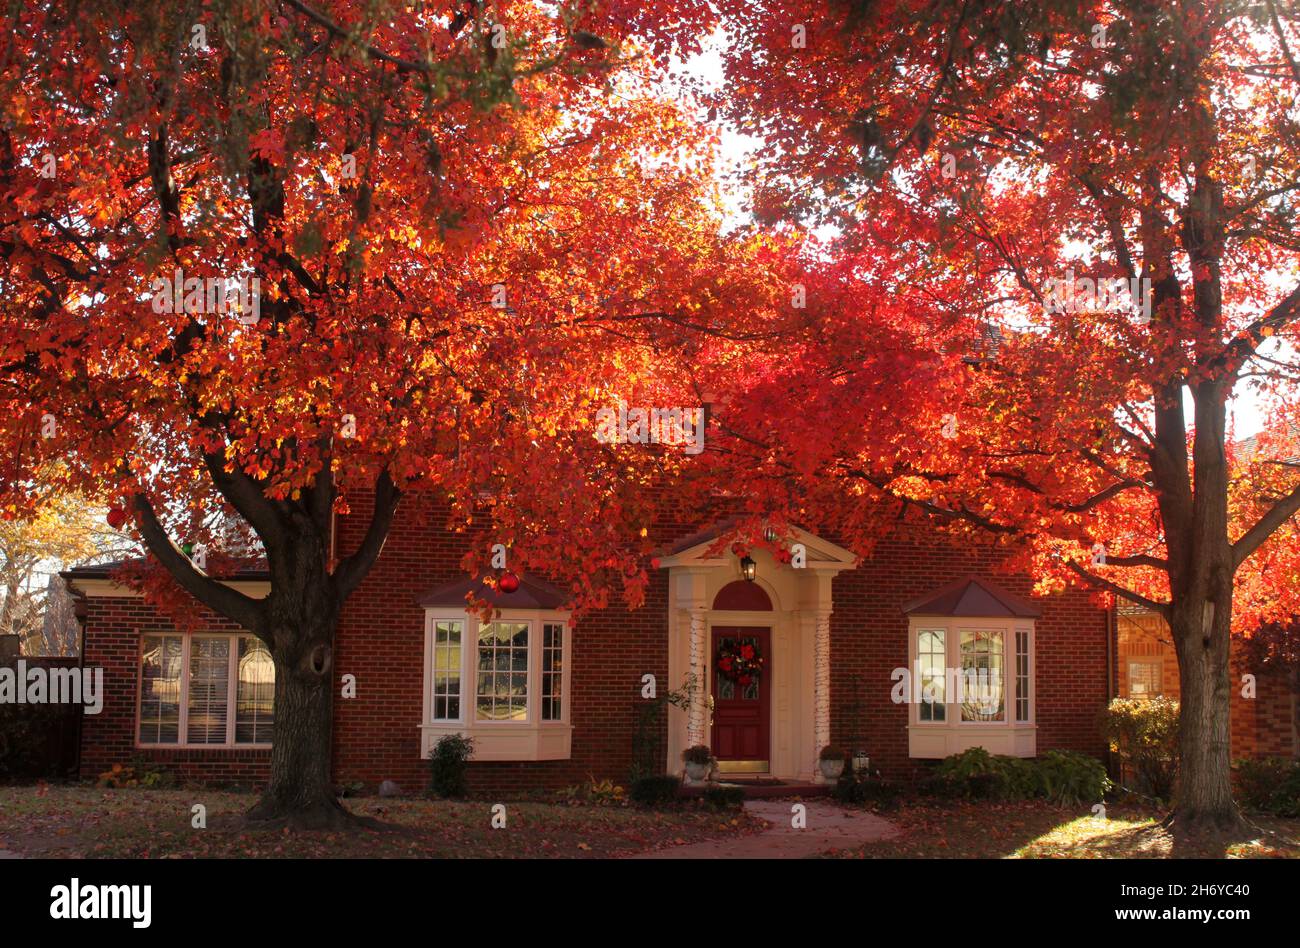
<box><xmin>0</xmin><ymin>784</ymin><xmax>762</xmax><ymax>858</ymax></box>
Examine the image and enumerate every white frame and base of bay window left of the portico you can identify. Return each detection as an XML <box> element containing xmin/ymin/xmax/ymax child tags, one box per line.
<box><xmin>420</xmin><ymin>609</ymin><xmax>573</xmax><ymax>761</ymax></box>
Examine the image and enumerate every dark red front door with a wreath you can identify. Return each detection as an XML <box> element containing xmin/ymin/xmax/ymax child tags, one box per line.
<box><xmin>710</xmin><ymin>625</ymin><xmax>772</xmax><ymax>772</ymax></box>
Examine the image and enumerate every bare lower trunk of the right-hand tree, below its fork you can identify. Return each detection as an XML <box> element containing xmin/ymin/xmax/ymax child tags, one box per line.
<box><xmin>1171</xmin><ymin>579</ymin><xmax>1243</xmax><ymax>834</ymax></box>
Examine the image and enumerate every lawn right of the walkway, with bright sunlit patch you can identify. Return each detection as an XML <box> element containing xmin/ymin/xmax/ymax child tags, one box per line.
<box><xmin>841</xmin><ymin>801</ymin><xmax>1300</xmax><ymax>860</ymax></box>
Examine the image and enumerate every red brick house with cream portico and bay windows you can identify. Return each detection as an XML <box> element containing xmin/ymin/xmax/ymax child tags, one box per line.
<box><xmin>65</xmin><ymin>505</ymin><xmax>1279</xmax><ymax>793</ymax></box>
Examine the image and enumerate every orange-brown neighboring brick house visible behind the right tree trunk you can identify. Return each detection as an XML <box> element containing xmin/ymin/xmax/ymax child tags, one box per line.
<box><xmin>1115</xmin><ymin>606</ymin><xmax>1300</xmax><ymax>758</ymax></box>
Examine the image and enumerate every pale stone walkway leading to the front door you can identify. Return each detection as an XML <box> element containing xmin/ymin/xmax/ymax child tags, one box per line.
<box><xmin>632</xmin><ymin>800</ymin><xmax>898</xmax><ymax>860</ymax></box>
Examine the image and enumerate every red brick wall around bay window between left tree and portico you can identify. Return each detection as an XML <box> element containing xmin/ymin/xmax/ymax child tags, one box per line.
<box><xmin>334</xmin><ymin>491</ymin><xmax>668</xmax><ymax>793</ymax></box>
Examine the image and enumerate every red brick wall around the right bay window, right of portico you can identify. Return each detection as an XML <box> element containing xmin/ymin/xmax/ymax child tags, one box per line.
<box><xmin>831</xmin><ymin>534</ymin><xmax>1108</xmax><ymax>779</ymax></box>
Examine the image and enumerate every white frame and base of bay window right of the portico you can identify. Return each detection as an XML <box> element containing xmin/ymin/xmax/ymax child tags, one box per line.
<box><xmin>907</xmin><ymin>615</ymin><xmax>1037</xmax><ymax>758</ymax></box>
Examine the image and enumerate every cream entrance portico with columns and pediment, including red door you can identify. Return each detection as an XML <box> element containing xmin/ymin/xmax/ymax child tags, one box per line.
<box><xmin>660</xmin><ymin>527</ymin><xmax>855</xmax><ymax>780</ymax></box>
